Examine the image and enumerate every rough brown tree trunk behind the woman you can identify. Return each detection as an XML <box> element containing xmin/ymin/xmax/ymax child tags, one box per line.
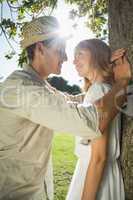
<box><xmin>108</xmin><ymin>0</ymin><xmax>133</xmax><ymax>200</ymax></box>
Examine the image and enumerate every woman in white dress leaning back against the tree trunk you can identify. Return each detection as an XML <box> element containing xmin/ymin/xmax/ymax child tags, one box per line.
<box><xmin>66</xmin><ymin>39</ymin><xmax>125</xmax><ymax>200</ymax></box>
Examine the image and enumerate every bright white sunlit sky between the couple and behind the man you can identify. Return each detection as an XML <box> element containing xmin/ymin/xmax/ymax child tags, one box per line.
<box><xmin>0</xmin><ymin>0</ymin><xmax>94</xmax><ymax>85</ymax></box>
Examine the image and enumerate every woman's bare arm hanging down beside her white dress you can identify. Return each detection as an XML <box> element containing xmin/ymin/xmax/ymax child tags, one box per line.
<box><xmin>82</xmin><ymin>131</ymin><xmax>109</xmax><ymax>200</ymax></box>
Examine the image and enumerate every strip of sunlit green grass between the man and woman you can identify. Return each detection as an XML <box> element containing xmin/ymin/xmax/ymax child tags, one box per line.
<box><xmin>53</xmin><ymin>134</ymin><xmax>76</xmax><ymax>200</ymax></box>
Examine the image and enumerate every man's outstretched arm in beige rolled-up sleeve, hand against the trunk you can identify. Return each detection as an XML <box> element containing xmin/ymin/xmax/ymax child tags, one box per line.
<box><xmin>0</xmin><ymin>55</ymin><xmax>129</xmax><ymax>139</ymax></box>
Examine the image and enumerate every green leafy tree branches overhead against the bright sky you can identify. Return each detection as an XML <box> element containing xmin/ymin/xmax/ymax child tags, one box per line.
<box><xmin>0</xmin><ymin>0</ymin><xmax>107</xmax><ymax>65</ymax></box>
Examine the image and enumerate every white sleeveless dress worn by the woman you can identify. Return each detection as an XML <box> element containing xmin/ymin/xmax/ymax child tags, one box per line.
<box><xmin>66</xmin><ymin>83</ymin><xmax>125</xmax><ymax>200</ymax></box>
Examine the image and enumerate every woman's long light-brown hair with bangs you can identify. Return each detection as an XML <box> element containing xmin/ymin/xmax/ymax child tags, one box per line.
<box><xmin>75</xmin><ymin>39</ymin><xmax>114</xmax><ymax>91</ymax></box>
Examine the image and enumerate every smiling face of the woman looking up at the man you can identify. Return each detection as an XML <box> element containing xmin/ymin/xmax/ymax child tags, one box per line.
<box><xmin>73</xmin><ymin>49</ymin><xmax>94</xmax><ymax>78</ymax></box>
